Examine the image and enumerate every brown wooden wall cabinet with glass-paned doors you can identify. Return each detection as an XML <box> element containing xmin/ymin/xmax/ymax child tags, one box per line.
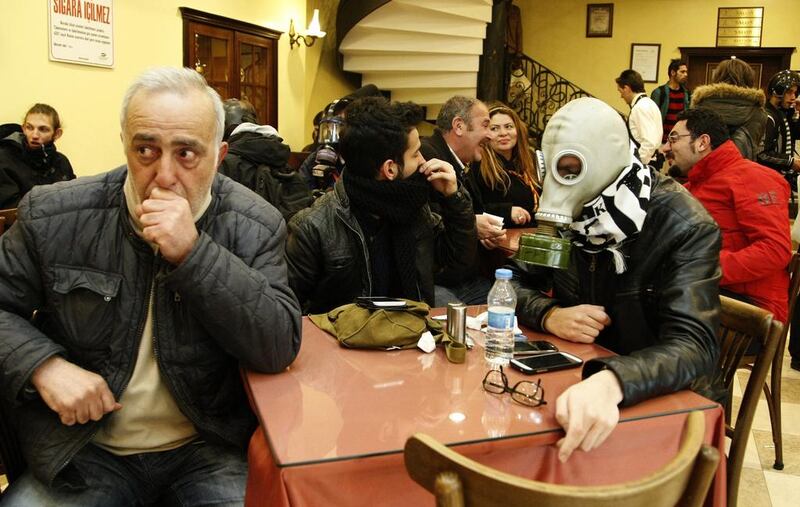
<box><xmin>180</xmin><ymin>7</ymin><xmax>281</xmax><ymax>128</ymax></box>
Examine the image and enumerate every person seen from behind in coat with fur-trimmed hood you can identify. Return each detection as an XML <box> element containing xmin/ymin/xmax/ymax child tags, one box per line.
<box><xmin>692</xmin><ymin>58</ymin><xmax>767</xmax><ymax>161</ymax></box>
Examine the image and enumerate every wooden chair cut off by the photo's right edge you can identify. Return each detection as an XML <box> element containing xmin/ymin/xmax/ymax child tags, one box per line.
<box><xmin>739</xmin><ymin>249</ymin><xmax>800</xmax><ymax>470</ymax></box>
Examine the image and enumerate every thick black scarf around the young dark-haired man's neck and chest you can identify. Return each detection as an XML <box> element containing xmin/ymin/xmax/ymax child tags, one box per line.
<box><xmin>342</xmin><ymin>171</ymin><xmax>430</xmax><ymax>300</ymax></box>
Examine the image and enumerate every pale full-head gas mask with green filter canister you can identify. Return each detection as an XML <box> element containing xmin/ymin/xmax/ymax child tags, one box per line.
<box><xmin>514</xmin><ymin>97</ymin><xmax>649</xmax><ymax>269</ymax></box>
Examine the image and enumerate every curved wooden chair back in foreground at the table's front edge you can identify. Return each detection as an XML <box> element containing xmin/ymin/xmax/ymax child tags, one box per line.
<box><xmin>405</xmin><ymin>412</ymin><xmax>719</xmax><ymax>507</ymax></box>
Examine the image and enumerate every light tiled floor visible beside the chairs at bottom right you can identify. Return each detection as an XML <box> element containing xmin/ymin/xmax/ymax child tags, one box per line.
<box><xmin>734</xmin><ymin>342</ymin><xmax>800</xmax><ymax>507</ymax></box>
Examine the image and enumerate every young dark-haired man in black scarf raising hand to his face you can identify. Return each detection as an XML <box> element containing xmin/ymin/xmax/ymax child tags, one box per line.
<box><xmin>286</xmin><ymin>97</ymin><xmax>477</xmax><ymax>313</ymax></box>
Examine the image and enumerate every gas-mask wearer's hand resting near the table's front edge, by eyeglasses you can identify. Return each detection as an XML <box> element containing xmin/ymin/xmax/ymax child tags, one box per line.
<box><xmin>556</xmin><ymin>370</ymin><xmax>622</xmax><ymax>463</ymax></box>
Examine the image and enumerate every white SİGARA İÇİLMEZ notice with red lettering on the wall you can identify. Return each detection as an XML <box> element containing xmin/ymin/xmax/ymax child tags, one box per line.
<box><xmin>47</xmin><ymin>0</ymin><xmax>114</xmax><ymax>67</ymax></box>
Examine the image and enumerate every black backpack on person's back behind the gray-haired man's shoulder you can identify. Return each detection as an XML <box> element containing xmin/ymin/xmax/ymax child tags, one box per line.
<box><xmin>253</xmin><ymin>165</ymin><xmax>314</xmax><ymax>222</ymax></box>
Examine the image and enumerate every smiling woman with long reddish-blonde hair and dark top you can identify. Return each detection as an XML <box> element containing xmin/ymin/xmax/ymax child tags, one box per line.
<box><xmin>469</xmin><ymin>103</ymin><xmax>541</xmax><ymax>227</ymax></box>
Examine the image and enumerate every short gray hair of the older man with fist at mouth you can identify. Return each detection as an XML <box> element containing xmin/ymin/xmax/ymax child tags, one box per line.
<box><xmin>119</xmin><ymin>67</ymin><xmax>225</xmax><ymax>143</ymax></box>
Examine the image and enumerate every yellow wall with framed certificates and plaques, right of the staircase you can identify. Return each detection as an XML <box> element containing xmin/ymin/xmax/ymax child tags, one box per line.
<box><xmin>515</xmin><ymin>0</ymin><xmax>800</xmax><ymax>110</ymax></box>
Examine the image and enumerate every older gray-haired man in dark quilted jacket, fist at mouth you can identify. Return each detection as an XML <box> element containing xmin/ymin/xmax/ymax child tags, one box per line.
<box><xmin>0</xmin><ymin>68</ymin><xmax>300</xmax><ymax>506</ymax></box>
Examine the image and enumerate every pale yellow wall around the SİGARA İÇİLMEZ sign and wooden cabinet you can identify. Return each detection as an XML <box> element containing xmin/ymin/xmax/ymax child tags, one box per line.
<box><xmin>0</xmin><ymin>0</ymin><xmax>339</xmax><ymax>176</ymax></box>
